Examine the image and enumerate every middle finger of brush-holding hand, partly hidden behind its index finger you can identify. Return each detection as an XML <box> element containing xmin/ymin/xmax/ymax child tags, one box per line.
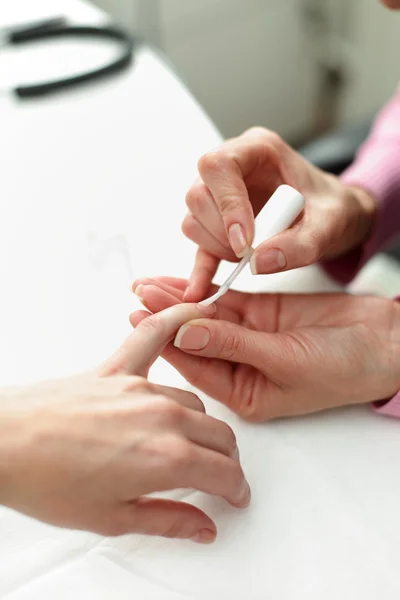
<box><xmin>186</xmin><ymin>177</ymin><xmax>231</xmax><ymax>250</ymax></box>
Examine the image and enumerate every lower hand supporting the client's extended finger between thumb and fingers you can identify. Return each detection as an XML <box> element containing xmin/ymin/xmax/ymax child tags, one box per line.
<box><xmin>131</xmin><ymin>278</ymin><xmax>400</xmax><ymax>421</ymax></box>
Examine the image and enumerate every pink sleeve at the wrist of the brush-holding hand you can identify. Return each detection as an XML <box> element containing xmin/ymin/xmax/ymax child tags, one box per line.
<box><xmin>324</xmin><ymin>91</ymin><xmax>400</xmax><ymax>284</ymax></box>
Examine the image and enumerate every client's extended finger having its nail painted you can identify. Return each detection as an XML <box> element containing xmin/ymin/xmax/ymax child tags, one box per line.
<box><xmin>100</xmin><ymin>304</ymin><xmax>216</xmax><ymax>376</ymax></box>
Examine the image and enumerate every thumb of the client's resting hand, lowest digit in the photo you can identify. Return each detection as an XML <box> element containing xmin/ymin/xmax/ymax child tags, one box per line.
<box><xmin>114</xmin><ymin>497</ymin><xmax>217</xmax><ymax>544</ymax></box>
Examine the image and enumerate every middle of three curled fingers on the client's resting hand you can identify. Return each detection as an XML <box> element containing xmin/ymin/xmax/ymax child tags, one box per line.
<box><xmin>182</xmin><ymin>411</ymin><xmax>239</xmax><ymax>460</ymax></box>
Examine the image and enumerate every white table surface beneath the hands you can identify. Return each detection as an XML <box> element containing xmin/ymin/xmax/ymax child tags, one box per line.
<box><xmin>0</xmin><ymin>0</ymin><xmax>400</xmax><ymax>600</ymax></box>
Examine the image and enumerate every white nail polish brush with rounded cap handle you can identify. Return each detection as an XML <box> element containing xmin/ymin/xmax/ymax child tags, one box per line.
<box><xmin>200</xmin><ymin>185</ymin><xmax>305</xmax><ymax>306</ymax></box>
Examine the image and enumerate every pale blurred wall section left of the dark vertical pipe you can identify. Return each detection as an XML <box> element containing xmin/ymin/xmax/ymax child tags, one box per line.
<box><xmin>162</xmin><ymin>0</ymin><xmax>317</xmax><ymax>138</ymax></box>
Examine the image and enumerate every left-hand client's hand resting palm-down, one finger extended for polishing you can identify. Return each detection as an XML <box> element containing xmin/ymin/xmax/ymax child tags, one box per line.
<box><xmin>0</xmin><ymin>305</ymin><xmax>250</xmax><ymax>543</ymax></box>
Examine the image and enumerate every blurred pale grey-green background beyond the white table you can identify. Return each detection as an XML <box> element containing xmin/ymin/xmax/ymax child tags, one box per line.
<box><xmin>96</xmin><ymin>0</ymin><xmax>400</xmax><ymax>145</ymax></box>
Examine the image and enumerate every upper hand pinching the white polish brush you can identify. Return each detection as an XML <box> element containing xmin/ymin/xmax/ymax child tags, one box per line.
<box><xmin>182</xmin><ymin>128</ymin><xmax>375</xmax><ymax>302</ymax></box>
